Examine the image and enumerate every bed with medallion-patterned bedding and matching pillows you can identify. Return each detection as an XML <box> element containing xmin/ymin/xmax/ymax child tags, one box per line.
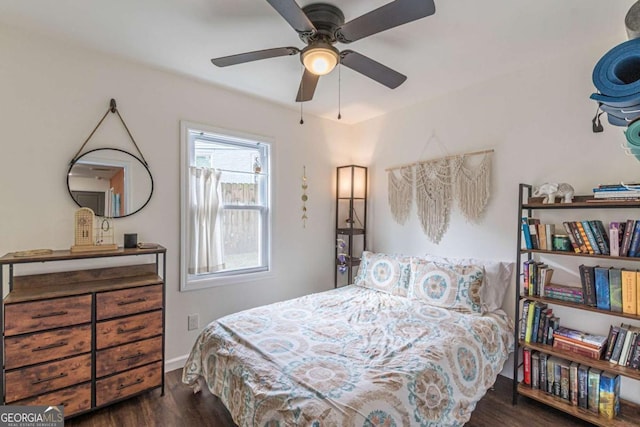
<box><xmin>183</xmin><ymin>252</ymin><xmax>513</xmax><ymax>427</ymax></box>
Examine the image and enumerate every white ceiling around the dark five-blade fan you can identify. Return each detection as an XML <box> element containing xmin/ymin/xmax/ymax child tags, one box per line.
<box><xmin>0</xmin><ymin>0</ymin><xmax>635</xmax><ymax>123</ymax></box>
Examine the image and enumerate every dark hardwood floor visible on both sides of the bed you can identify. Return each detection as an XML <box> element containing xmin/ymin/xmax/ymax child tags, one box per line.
<box><xmin>65</xmin><ymin>370</ymin><xmax>591</xmax><ymax>427</ymax></box>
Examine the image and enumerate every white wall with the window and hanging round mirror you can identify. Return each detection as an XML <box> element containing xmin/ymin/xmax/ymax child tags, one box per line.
<box><xmin>0</xmin><ymin>28</ymin><xmax>352</xmax><ymax>370</ymax></box>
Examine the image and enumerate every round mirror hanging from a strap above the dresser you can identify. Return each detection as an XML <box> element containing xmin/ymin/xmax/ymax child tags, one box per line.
<box><xmin>67</xmin><ymin>148</ymin><xmax>153</xmax><ymax>218</ymax></box>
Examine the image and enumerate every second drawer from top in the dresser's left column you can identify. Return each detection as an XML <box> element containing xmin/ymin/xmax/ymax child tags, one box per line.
<box><xmin>5</xmin><ymin>325</ymin><xmax>91</xmax><ymax>369</ymax></box>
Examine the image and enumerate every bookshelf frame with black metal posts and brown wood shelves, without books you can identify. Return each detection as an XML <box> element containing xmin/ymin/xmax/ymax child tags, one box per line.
<box><xmin>513</xmin><ymin>184</ymin><xmax>640</xmax><ymax>427</ymax></box>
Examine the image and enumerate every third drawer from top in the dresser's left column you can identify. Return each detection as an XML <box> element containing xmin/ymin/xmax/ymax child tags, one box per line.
<box><xmin>5</xmin><ymin>354</ymin><xmax>91</xmax><ymax>403</ymax></box>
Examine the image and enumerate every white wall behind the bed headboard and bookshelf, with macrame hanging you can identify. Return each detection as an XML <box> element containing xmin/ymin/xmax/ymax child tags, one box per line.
<box><xmin>355</xmin><ymin>35</ymin><xmax>640</xmax><ymax>401</ymax></box>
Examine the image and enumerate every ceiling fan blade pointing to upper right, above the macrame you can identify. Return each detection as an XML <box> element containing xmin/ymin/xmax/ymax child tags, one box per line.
<box><xmin>336</xmin><ymin>0</ymin><xmax>436</xmax><ymax>43</ymax></box>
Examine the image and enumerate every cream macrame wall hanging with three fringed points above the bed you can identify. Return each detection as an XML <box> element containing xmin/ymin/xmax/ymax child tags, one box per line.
<box><xmin>386</xmin><ymin>144</ymin><xmax>493</xmax><ymax>243</ymax></box>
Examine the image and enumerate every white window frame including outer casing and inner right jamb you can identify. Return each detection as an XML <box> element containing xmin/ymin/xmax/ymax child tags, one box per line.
<box><xmin>180</xmin><ymin>121</ymin><xmax>273</xmax><ymax>291</ymax></box>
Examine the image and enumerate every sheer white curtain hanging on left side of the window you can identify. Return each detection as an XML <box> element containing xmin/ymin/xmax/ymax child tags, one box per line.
<box><xmin>188</xmin><ymin>166</ymin><xmax>224</xmax><ymax>274</ymax></box>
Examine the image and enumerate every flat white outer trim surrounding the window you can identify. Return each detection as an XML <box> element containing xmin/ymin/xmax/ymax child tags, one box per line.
<box><xmin>180</xmin><ymin>120</ymin><xmax>275</xmax><ymax>292</ymax></box>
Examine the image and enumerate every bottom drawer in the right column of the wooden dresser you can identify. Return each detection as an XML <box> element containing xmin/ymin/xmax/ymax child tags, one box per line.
<box><xmin>96</xmin><ymin>362</ymin><xmax>162</xmax><ymax>406</ymax></box>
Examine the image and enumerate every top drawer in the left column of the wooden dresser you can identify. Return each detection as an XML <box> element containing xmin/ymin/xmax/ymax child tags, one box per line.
<box><xmin>4</xmin><ymin>295</ymin><xmax>91</xmax><ymax>336</ymax></box>
